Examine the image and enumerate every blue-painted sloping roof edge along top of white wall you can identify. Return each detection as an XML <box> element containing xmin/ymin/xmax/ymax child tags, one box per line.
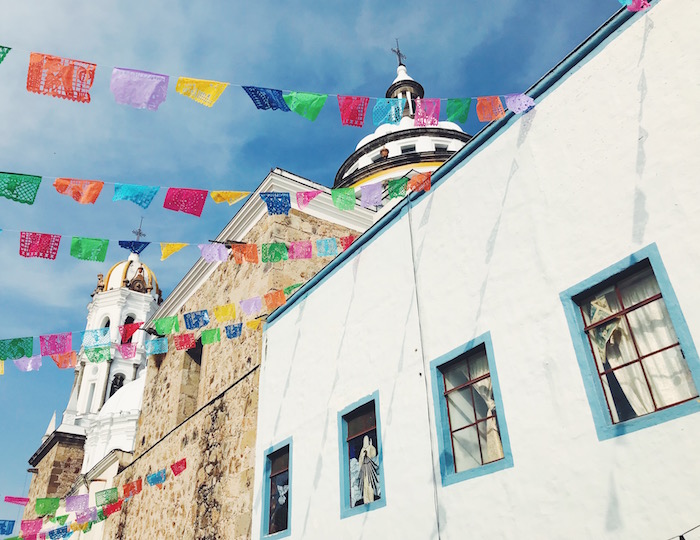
<box><xmin>264</xmin><ymin>0</ymin><xmax>644</xmax><ymax>329</ymax></box>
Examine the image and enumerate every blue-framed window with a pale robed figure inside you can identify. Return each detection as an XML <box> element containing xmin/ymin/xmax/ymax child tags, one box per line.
<box><xmin>338</xmin><ymin>391</ymin><xmax>386</xmax><ymax>519</ymax></box>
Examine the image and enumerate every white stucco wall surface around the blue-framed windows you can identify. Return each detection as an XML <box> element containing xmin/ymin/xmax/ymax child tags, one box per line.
<box><xmin>253</xmin><ymin>0</ymin><xmax>700</xmax><ymax>540</ymax></box>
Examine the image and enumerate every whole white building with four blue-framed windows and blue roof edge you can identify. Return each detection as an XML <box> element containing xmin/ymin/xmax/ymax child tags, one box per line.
<box><xmin>252</xmin><ymin>0</ymin><xmax>700</xmax><ymax>540</ymax></box>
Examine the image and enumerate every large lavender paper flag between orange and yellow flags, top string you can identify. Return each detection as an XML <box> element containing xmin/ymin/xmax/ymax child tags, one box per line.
<box><xmin>109</xmin><ymin>68</ymin><xmax>170</xmax><ymax>111</ymax></box>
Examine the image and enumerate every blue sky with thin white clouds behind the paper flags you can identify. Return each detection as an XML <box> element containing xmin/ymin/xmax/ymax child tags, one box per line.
<box><xmin>0</xmin><ymin>0</ymin><xmax>620</xmax><ymax>530</ymax></box>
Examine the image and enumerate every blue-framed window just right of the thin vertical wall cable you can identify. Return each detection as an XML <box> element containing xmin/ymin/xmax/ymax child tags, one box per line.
<box><xmin>430</xmin><ymin>332</ymin><xmax>513</xmax><ymax>486</ymax></box>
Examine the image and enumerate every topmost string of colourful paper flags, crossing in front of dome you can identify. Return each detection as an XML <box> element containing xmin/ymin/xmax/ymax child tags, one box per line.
<box><xmin>0</xmin><ymin>44</ymin><xmax>540</xmax><ymax>127</ymax></box>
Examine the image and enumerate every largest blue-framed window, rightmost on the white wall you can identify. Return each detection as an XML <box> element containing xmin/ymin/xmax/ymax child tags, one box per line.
<box><xmin>560</xmin><ymin>244</ymin><xmax>700</xmax><ymax>441</ymax></box>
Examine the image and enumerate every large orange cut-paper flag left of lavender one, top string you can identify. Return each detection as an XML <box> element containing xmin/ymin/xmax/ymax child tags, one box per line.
<box><xmin>27</xmin><ymin>53</ymin><xmax>97</xmax><ymax>103</ymax></box>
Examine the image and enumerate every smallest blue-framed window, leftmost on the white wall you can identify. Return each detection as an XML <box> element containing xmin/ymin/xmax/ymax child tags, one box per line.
<box><xmin>260</xmin><ymin>437</ymin><xmax>292</xmax><ymax>539</ymax></box>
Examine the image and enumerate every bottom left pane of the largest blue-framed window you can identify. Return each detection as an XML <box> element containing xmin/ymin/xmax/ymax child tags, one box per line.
<box><xmin>601</xmin><ymin>363</ymin><xmax>654</xmax><ymax>422</ymax></box>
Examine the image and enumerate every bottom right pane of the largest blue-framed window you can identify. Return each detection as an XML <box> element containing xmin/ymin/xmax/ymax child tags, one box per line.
<box><xmin>642</xmin><ymin>346</ymin><xmax>698</xmax><ymax>407</ymax></box>
